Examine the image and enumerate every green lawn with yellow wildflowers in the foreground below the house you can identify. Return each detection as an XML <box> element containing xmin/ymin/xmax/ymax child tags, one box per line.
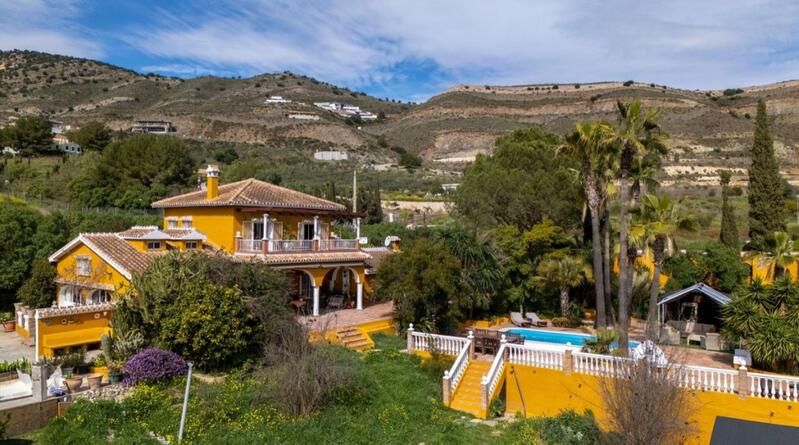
<box><xmin>26</xmin><ymin>336</ymin><xmax>598</xmax><ymax>445</ymax></box>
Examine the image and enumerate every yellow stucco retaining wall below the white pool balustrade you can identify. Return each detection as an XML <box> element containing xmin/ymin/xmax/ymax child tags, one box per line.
<box><xmin>505</xmin><ymin>365</ymin><xmax>799</xmax><ymax>444</ymax></box>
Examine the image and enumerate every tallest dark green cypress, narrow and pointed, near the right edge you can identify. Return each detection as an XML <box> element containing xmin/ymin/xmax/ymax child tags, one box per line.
<box><xmin>749</xmin><ymin>99</ymin><xmax>785</xmax><ymax>248</ymax></box>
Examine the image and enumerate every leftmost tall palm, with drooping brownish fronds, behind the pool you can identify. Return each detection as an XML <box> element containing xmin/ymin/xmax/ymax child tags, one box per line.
<box><xmin>558</xmin><ymin>122</ymin><xmax>614</xmax><ymax>328</ymax></box>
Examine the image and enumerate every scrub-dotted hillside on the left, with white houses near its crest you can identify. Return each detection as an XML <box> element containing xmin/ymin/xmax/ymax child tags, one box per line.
<box><xmin>0</xmin><ymin>51</ymin><xmax>410</xmax><ymax>155</ymax></box>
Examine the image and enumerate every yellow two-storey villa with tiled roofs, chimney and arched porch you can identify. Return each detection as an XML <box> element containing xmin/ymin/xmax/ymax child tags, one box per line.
<box><xmin>16</xmin><ymin>166</ymin><xmax>382</xmax><ymax>357</ymax></box>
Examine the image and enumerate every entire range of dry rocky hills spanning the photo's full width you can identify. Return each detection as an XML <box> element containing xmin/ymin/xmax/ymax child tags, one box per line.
<box><xmin>0</xmin><ymin>51</ymin><xmax>799</xmax><ymax>186</ymax></box>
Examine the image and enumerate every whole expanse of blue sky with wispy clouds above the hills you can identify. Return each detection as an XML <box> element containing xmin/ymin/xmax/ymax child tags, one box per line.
<box><xmin>0</xmin><ymin>0</ymin><xmax>799</xmax><ymax>101</ymax></box>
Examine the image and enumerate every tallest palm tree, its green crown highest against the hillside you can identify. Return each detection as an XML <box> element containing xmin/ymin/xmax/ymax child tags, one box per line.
<box><xmin>616</xmin><ymin>101</ymin><xmax>666</xmax><ymax>355</ymax></box>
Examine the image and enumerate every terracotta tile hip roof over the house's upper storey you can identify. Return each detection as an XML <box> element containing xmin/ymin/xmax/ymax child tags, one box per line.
<box><xmin>152</xmin><ymin>179</ymin><xmax>347</xmax><ymax>212</ymax></box>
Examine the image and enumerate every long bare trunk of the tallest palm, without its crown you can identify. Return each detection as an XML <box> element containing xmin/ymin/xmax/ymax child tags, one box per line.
<box><xmin>618</xmin><ymin>147</ymin><xmax>633</xmax><ymax>357</ymax></box>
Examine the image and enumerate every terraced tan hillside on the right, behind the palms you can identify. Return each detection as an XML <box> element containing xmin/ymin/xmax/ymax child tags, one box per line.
<box><xmin>376</xmin><ymin>81</ymin><xmax>799</xmax><ymax>186</ymax></box>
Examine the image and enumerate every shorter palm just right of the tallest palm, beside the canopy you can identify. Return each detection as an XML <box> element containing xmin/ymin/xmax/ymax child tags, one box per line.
<box><xmin>630</xmin><ymin>195</ymin><xmax>694</xmax><ymax>340</ymax></box>
